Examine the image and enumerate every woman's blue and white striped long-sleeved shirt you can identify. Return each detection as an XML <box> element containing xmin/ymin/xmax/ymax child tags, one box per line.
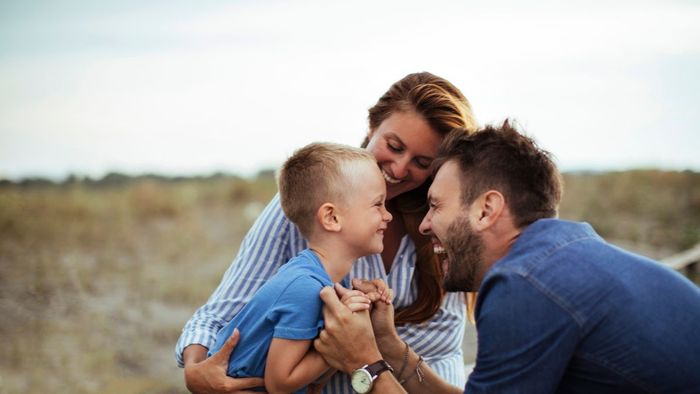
<box><xmin>175</xmin><ymin>195</ymin><xmax>466</xmax><ymax>394</ymax></box>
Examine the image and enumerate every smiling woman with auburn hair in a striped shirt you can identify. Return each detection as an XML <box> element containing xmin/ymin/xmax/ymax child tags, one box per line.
<box><xmin>175</xmin><ymin>72</ymin><xmax>476</xmax><ymax>393</ymax></box>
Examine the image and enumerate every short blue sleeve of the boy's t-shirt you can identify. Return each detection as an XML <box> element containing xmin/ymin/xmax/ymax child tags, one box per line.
<box><xmin>267</xmin><ymin>276</ymin><xmax>323</xmax><ymax>340</ymax></box>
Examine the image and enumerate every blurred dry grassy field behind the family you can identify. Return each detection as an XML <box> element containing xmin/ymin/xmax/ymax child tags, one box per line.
<box><xmin>0</xmin><ymin>171</ymin><xmax>700</xmax><ymax>394</ymax></box>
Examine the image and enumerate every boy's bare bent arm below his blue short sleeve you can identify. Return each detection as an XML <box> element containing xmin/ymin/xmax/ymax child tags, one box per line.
<box><xmin>265</xmin><ymin>338</ymin><xmax>329</xmax><ymax>394</ymax></box>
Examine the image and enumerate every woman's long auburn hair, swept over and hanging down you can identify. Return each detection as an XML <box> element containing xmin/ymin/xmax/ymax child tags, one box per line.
<box><xmin>362</xmin><ymin>72</ymin><xmax>477</xmax><ymax>325</ymax></box>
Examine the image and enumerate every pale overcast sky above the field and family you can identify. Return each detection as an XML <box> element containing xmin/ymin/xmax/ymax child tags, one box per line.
<box><xmin>0</xmin><ymin>0</ymin><xmax>700</xmax><ymax>179</ymax></box>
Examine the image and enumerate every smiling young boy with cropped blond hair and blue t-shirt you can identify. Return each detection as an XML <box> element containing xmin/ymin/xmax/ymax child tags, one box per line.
<box><xmin>209</xmin><ymin>143</ymin><xmax>391</xmax><ymax>393</ymax></box>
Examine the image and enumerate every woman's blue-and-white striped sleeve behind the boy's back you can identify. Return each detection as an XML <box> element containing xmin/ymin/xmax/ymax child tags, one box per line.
<box><xmin>175</xmin><ymin>195</ymin><xmax>300</xmax><ymax>367</ymax></box>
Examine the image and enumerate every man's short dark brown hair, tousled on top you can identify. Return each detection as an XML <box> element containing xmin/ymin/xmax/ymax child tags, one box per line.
<box><xmin>433</xmin><ymin>120</ymin><xmax>562</xmax><ymax>227</ymax></box>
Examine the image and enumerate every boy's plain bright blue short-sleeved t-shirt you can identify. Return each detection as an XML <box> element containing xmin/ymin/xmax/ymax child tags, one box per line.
<box><xmin>209</xmin><ymin>249</ymin><xmax>333</xmax><ymax>390</ymax></box>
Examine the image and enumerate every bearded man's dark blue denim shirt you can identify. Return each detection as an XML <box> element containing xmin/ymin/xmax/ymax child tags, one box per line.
<box><xmin>465</xmin><ymin>219</ymin><xmax>700</xmax><ymax>394</ymax></box>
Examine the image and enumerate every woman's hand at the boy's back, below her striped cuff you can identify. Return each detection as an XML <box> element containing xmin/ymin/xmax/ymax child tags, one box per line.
<box><xmin>184</xmin><ymin>329</ymin><xmax>265</xmax><ymax>394</ymax></box>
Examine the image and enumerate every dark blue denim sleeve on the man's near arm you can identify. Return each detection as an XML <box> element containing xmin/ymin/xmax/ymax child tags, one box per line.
<box><xmin>466</xmin><ymin>273</ymin><xmax>580</xmax><ymax>394</ymax></box>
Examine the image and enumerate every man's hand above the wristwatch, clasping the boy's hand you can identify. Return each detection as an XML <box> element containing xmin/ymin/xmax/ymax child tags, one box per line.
<box><xmin>314</xmin><ymin>287</ymin><xmax>382</xmax><ymax>373</ymax></box>
